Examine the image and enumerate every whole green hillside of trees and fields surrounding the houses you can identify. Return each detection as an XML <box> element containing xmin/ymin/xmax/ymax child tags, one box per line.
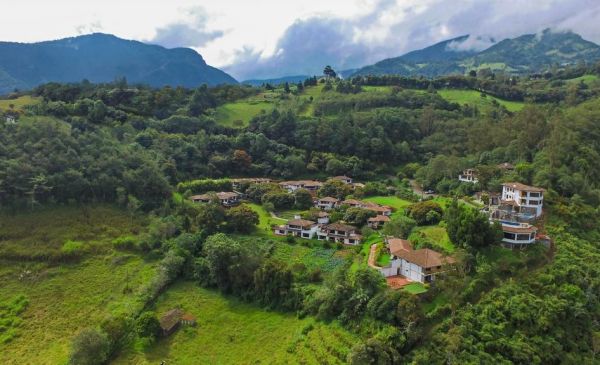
<box><xmin>0</xmin><ymin>61</ymin><xmax>600</xmax><ymax>364</ymax></box>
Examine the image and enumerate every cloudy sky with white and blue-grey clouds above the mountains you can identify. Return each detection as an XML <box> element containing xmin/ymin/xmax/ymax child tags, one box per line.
<box><xmin>0</xmin><ymin>0</ymin><xmax>600</xmax><ymax>80</ymax></box>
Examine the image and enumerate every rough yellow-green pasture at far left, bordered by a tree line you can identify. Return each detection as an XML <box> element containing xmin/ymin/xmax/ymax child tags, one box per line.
<box><xmin>0</xmin><ymin>206</ymin><xmax>154</xmax><ymax>364</ymax></box>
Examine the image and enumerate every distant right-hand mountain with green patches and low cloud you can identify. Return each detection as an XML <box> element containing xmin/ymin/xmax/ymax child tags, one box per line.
<box><xmin>353</xmin><ymin>30</ymin><xmax>600</xmax><ymax>77</ymax></box>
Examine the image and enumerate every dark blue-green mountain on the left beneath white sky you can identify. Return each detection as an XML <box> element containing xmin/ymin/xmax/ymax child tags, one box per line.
<box><xmin>0</xmin><ymin>33</ymin><xmax>237</xmax><ymax>93</ymax></box>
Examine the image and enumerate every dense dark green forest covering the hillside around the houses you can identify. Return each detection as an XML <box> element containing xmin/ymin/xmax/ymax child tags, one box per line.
<box><xmin>0</xmin><ymin>65</ymin><xmax>600</xmax><ymax>364</ymax></box>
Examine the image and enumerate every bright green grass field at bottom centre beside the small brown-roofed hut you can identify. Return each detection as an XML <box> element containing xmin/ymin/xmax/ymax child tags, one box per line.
<box><xmin>114</xmin><ymin>282</ymin><xmax>358</xmax><ymax>364</ymax></box>
